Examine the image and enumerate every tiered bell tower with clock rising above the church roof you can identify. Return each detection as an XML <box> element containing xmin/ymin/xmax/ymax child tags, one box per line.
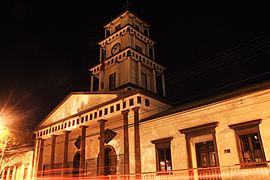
<box><xmin>89</xmin><ymin>10</ymin><xmax>166</xmax><ymax>97</ymax></box>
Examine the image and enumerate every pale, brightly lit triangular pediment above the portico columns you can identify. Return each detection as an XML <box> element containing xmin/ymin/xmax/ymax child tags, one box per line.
<box><xmin>37</xmin><ymin>93</ymin><xmax>117</xmax><ymax>128</ymax></box>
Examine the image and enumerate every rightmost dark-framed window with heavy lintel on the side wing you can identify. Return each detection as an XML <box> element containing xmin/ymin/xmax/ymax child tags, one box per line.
<box><xmin>229</xmin><ymin>119</ymin><xmax>265</xmax><ymax>167</ymax></box>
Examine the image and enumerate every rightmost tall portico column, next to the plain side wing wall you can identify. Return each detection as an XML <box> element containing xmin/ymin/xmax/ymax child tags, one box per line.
<box><xmin>132</xmin><ymin>107</ymin><xmax>141</xmax><ymax>174</ymax></box>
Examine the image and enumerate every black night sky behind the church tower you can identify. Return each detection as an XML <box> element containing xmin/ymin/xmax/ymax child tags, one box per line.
<box><xmin>0</xmin><ymin>0</ymin><xmax>270</xmax><ymax>129</ymax></box>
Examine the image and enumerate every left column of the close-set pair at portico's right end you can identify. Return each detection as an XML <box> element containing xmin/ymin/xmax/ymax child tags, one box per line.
<box><xmin>122</xmin><ymin>109</ymin><xmax>129</xmax><ymax>174</ymax></box>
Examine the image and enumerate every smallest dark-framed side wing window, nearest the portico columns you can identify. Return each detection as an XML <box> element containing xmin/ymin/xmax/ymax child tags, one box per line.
<box><xmin>151</xmin><ymin>137</ymin><xmax>172</xmax><ymax>171</ymax></box>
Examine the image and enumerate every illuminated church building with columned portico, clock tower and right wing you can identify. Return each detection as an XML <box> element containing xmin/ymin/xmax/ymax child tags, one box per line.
<box><xmin>33</xmin><ymin>11</ymin><xmax>270</xmax><ymax>179</ymax></box>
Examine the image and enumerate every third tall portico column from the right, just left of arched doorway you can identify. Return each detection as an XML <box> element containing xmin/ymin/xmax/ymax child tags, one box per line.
<box><xmin>98</xmin><ymin>119</ymin><xmax>107</xmax><ymax>175</ymax></box>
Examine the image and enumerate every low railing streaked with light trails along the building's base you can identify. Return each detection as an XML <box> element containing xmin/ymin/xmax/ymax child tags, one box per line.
<box><xmin>36</xmin><ymin>163</ymin><xmax>270</xmax><ymax>180</ymax></box>
